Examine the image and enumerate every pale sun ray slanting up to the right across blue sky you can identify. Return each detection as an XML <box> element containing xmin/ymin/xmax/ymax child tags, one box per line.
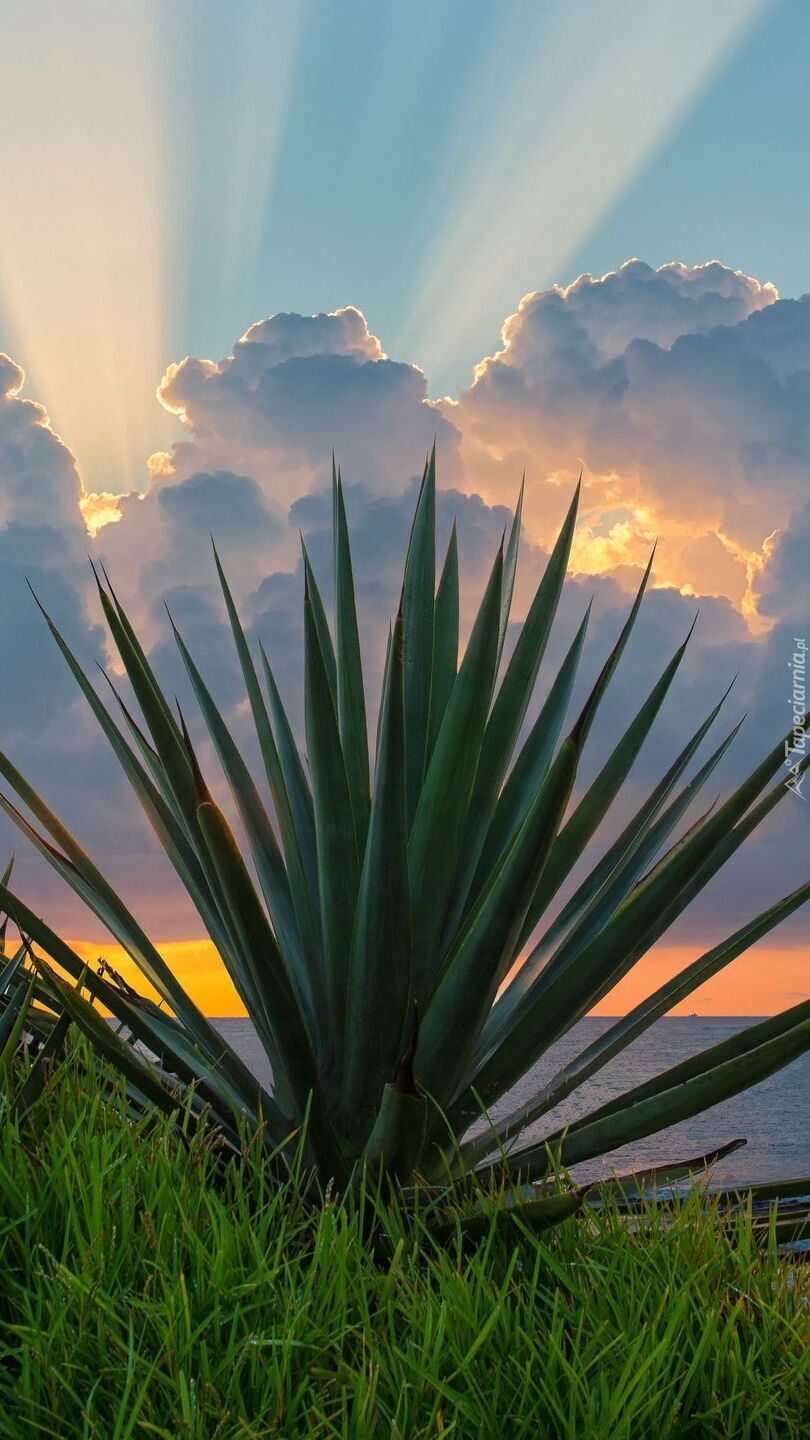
<box><xmin>395</xmin><ymin>0</ymin><xmax>770</xmax><ymax>383</ymax></box>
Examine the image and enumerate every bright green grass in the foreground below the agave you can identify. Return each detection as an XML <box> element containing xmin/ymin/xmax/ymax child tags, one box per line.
<box><xmin>0</xmin><ymin>1057</ymin><xmax>810</xmax><ymax>1440</ymax></box>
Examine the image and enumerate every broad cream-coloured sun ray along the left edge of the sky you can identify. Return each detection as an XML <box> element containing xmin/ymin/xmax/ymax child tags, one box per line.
<box><xmin>0</xmin><ymin>0</ymin><xmax>176</xmax><ymax>491</ymax></box>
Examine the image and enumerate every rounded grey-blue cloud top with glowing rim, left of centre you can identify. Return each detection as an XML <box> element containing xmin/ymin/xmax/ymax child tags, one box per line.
<box><xmin>149</xmin><ymin>307</ymin><xmax>457</xmax><ymax>504</ymax></box>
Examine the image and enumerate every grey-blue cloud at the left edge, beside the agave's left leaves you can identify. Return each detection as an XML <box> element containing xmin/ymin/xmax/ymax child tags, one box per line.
<box><xmin>0</xmin><ymin>357</ymin><xmax>167</xmax><ymax>933</ymax></box>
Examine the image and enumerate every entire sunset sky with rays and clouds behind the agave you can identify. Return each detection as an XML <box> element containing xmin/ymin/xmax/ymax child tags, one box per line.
<box><xmin>0</xmin><ymin>0</ymin><xmax>810</xmax><ymax>1014</ymax></box>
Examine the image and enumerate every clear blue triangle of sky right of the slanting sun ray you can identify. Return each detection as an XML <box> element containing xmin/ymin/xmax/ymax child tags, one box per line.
<box><xmin>571</xmin><ymin>0</ymin><xmax>810</xmax><ymax>306</ymax></box>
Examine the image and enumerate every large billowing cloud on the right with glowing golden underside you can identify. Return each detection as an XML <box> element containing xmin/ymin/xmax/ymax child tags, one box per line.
<box><xmin>442</xmin><ymin>261</ymin><xmax>810</xmax><ymax>613</ymax></box>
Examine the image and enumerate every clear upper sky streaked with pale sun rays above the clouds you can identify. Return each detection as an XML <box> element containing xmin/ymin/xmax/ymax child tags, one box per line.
<box><xmin>0</xmin><ymin>0</ymin><xmax>810</xmax><ymax>490</ymax></box>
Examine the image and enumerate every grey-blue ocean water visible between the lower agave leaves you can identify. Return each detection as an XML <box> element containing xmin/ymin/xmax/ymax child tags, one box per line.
<box><xmin>215</xmin><ymin>1015</ymin><xmax>810</xmax><ymax>1185</ymax></box>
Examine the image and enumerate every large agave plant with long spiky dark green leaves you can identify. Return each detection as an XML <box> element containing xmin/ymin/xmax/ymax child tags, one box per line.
<box><xmin>0</xmin><ymin>455</ymin><xmax>810</xmax><ymax>1184</ymax></box>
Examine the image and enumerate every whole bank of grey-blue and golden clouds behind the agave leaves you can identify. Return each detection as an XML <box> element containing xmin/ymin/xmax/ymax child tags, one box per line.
<box><xmin>0</xmin><ymin>261</ymin><xmax>810</xmax><ymax>973</ymax></box>
